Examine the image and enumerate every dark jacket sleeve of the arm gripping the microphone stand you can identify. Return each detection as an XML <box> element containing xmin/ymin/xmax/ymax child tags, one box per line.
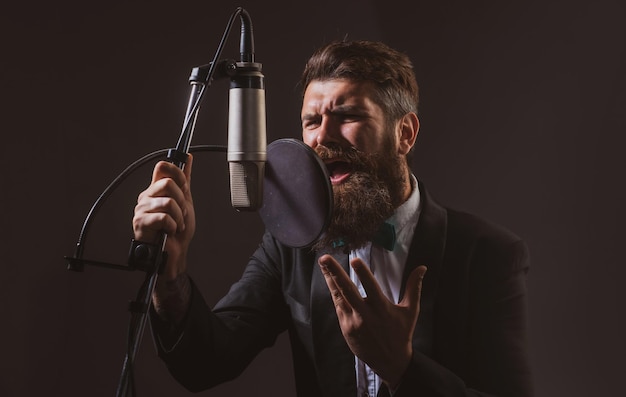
<box><xmin>150</xmin><ymin>230</ymin><xmax>288</xmax><ymax>392</ymax></box>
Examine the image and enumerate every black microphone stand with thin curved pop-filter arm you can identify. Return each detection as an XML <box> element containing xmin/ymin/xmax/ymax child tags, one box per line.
<box><xmin>65</xmin><ymin>7</ymin><xmax>262</xmax><ymax>397</ymax></box>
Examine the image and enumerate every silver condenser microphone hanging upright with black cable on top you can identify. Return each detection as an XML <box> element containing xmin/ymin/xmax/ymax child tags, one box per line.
<box><xmin>227</xmin><ymin>10</ymin><xmax>267</xmax><ymax>211</ymax></box>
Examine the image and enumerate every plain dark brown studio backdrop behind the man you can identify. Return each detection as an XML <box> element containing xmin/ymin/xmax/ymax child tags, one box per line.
<box><xmin>0</xmin><ymin>0</ymin><xmax>626</xmax><ymax>397</ymax></box>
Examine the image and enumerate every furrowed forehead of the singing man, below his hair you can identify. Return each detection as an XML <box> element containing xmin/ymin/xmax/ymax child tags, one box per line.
<box><xmin>302</xmin><ymin>79</ymin><xmax>376</xmax><ymax>112</ymax></box>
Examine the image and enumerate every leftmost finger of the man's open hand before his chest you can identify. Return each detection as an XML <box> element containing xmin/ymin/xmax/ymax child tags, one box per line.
<box><xmin>319</xmin><ymin>255</ymin><xmax>362</xmax><ymax>313</ymax></box>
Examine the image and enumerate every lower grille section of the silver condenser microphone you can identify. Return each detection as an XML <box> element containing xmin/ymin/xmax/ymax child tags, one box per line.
<box><xmin>228</xmin><ymin>161</ymin><xmax>265</xmax><ymax>211</ymax></box>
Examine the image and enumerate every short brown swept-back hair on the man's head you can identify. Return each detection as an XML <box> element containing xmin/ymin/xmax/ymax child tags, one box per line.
<box><xmin>300</xmin><ymin>40</ymin><xmax>419</xmax><ymax>122</ymax></box>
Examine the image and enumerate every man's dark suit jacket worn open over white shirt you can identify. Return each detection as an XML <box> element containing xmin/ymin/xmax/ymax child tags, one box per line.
<box><xmin>151</xmin><ymin>185</ymin><xmax>532</xmax><ymax>397</ymax></box>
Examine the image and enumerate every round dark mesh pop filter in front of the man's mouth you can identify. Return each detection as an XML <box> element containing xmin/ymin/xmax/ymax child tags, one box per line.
<box><xmin>259</xmin><ymin>138</ymin><xmax>333</xmax><ymax>248</ymax></box>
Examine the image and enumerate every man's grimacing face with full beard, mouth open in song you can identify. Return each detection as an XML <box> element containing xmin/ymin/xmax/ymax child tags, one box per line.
<box><xmin>301</xmin><ymin>79</ymin><xmax>411</xmax><ymax>249</ymax></box>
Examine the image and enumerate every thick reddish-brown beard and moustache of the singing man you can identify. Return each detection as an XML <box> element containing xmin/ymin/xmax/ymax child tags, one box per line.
<box><xmin>313</xmin><ymin>142</ymin><xmax>409</xmax><ymax>251</ymax></box>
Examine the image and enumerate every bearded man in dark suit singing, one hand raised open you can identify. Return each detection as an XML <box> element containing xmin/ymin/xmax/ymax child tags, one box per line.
<box><xmin>133</xmin><ymin>41</ymin><xmax>532</xmax><ymax>397</ymax></box>
